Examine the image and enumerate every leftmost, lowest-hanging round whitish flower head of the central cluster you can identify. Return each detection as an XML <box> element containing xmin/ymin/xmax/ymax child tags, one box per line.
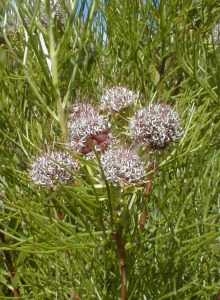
<box><xmin>30</xmin><ymin>151</ymin><xmax>78</xmax><ymax>187</ymax></box>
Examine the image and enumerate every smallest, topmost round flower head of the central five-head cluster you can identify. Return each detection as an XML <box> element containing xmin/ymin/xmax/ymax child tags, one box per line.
<box><xmin>100</xmin><ymin>86</ymin><xmax>137</xmax><ymax>112</ymax></box>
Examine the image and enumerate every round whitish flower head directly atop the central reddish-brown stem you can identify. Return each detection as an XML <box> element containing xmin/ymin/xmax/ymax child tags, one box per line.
<box><xmin>100</xmin><ymin>148</ymin><xmax>146</xmax><ymax>186</ymax></box>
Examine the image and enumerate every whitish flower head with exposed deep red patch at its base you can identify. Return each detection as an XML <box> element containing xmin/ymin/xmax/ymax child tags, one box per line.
<box><xmin>68</xmin><ymin>103</ymin><xmax>111</xmax><ymax>154</ymax></box>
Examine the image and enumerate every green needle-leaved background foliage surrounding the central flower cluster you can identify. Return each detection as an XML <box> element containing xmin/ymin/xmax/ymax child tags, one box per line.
<box><xmin>0</xmin><ymin>0</ymin><xmax>220</xmax><ymax>300</ymax></box>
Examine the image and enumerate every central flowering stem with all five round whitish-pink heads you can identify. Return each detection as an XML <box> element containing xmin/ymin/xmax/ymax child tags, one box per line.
<box><xmin>30</xmin><ymin>87</ymin><xmax>182</xmax><ymax>300</ymax></box>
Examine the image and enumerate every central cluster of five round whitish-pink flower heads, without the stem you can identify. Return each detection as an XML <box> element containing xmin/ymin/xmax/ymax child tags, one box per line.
<box><xmin>30</xmin><ymin>87</ymin><xmax>183</xmax><ymax>187</ymax></box>
